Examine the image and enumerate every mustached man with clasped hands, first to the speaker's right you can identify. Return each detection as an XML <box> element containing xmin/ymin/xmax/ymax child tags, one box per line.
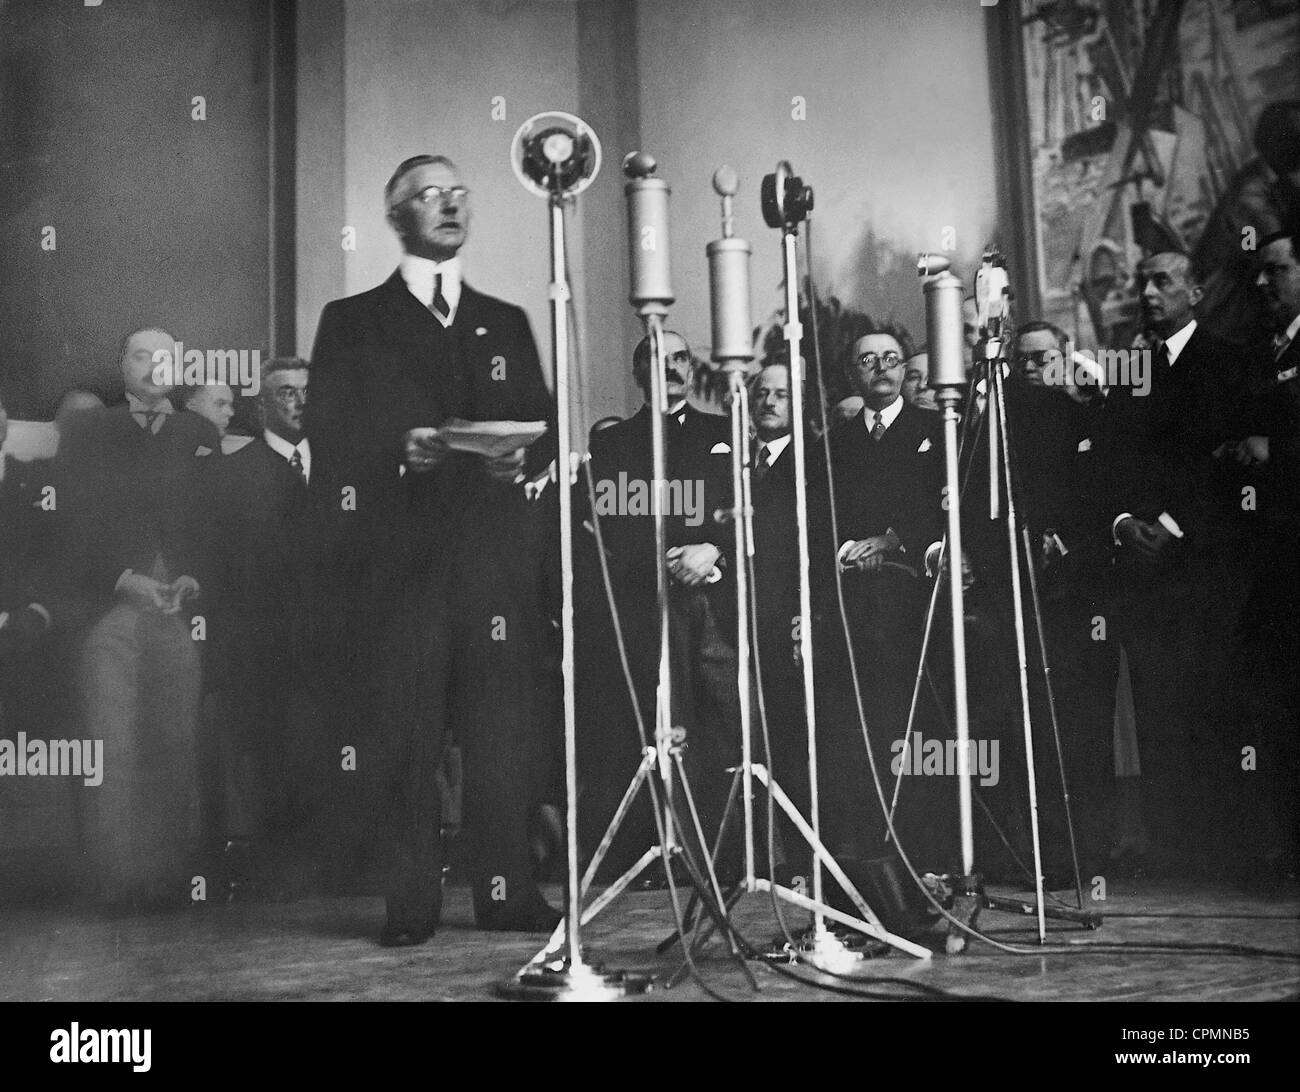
<box><xmin>579</xmin><ymin>330</ymin><xmax>738</xmax><ymax>859</ymax></box>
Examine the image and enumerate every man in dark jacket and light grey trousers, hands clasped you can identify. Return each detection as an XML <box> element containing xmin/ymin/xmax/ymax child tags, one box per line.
<box><xmin>55</xmin><ymin>328</ymin><xmax>221</xmax><ymax>907</ymax></box>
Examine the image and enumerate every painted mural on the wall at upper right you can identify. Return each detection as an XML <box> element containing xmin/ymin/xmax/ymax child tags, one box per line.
<box><xmin>1019</xmin><ymin>0</ymin><xmax>1300</xmax><ymax>346</ymax></box>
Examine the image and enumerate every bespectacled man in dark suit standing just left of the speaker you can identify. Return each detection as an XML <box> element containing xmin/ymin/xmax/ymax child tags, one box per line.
<box><xmin>191</xmin><ymin>356</ymin><xmax>322</xmax><ymax>896</ymax></box>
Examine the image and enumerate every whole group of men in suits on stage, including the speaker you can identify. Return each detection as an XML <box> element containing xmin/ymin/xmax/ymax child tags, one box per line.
<box><xmin>0</xmin><ymin>146</ymin><xmax>1300</xmax><ymax>945</ymax></box>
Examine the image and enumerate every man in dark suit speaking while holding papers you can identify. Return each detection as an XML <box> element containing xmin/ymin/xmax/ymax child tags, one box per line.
<box><xmin>314</xmin><ymin>156</ymin><xmax>559</xmax><ymax>945</ymax></box>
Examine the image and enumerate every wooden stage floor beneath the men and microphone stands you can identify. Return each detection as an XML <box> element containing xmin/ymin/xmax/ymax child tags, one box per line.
<box><xmin>0</xmin><ymin>881</ymin><xmax>1300</xmax><ymax>1002</ymax></box>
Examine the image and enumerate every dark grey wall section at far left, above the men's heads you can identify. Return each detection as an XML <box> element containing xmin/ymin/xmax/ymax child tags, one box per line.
<box><xmin>0</xmin><ymin>0</ymin><xmax>272</xmax><ymax>417</ymax></box>
